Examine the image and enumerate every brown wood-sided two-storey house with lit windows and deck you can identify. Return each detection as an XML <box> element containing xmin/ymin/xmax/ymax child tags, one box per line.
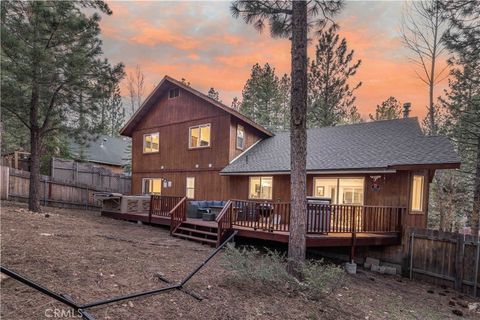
<box><xmin>113</xmin><ymin>76</ymin><xmax>460</xmax><ymax>264</ymax></box>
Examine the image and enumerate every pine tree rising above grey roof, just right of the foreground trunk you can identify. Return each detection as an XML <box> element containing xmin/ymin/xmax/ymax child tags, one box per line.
<box><xmin>308</xmin><ymin>27</ymin><xmax>362</xmax><ymax>127</ymax></box>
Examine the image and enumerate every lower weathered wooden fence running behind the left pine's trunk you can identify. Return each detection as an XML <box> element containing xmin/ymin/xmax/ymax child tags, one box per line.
<box><xmin>0</xmin><ymin>166</ymin><xmax>120</xmax><ymax>209</ymax></box>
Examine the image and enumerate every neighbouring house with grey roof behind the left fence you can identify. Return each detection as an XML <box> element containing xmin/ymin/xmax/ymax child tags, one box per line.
<box><xmin>69</xmin><ymin>135</ymin><xmax>130</xmax><ymax>173</ymax></box>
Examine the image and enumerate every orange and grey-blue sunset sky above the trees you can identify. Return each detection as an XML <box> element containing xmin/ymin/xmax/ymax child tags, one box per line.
<box><xmin>101</xmin><ymin>1</ymin><xmax>447</xmax><ymax>118</ymax></box>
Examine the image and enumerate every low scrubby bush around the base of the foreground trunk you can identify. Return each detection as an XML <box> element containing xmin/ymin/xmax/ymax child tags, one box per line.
<box><xmin>223</xmin><ymin>244</ymin><xmax>345</xmax><ymax>298</ymax></box>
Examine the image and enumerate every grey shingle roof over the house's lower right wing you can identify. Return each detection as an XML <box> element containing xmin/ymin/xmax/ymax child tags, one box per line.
<box><xmin>221</xmin><ymin>118</ymin><xmax>460</xmax><ymax>174</ymax></box>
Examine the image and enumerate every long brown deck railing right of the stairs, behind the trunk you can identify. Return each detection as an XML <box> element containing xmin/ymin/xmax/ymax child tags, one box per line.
<box><xmin>231</xmin><ymin>200</ymin><xmax>406</xmax><ymax>234</ymax></box>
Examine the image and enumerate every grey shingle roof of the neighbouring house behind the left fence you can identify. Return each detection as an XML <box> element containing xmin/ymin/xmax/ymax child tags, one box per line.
<box><xmin>69</xmin><ymin>136</ymin><xmax>130</xmax><ymax>166</ymax></box>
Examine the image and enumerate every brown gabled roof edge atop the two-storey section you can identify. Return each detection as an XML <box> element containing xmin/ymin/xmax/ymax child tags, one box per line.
<box><xmin>120</xmin><ymin>76</ymin><xmax>273</xmax><ymax>137</ymax></box>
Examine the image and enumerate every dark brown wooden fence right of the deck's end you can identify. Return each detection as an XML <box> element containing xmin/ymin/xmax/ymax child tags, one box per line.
<box><xmin>407</xmin><ymin>228</ymin><xmax>480</xmax><ymax>296</ymax></box>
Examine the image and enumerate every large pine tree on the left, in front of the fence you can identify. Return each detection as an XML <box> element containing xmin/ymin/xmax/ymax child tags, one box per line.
<box><xmin>1</xmin><ymin>0</ymin><xmax>123</xmax><ymax>211</ymax></box>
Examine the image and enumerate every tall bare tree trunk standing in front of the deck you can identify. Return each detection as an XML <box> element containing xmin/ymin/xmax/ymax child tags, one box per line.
<box><xmin>287</xmin><ymin>1</ymin><xmax>307</xmax><ymax>277</ymax></box>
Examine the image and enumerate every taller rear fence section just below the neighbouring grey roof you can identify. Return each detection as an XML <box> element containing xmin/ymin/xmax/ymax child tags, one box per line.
<box><xmin>51</xmin><ymin>158</ymin><xmax>131</xmax><ymax>194</ymax></box>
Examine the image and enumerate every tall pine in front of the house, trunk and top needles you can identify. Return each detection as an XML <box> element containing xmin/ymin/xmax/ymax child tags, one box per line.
<box><xmin>231</xmin><ymin>0</ymin><xmax>343</xmax><ymax>277</ymax></box>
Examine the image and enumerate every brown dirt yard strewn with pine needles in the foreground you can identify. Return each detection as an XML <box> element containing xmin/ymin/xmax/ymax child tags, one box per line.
<box><xmin>0</xmin><ymin>202</ymin><xmax>480</xmax><ymax>319</ymax></box>
